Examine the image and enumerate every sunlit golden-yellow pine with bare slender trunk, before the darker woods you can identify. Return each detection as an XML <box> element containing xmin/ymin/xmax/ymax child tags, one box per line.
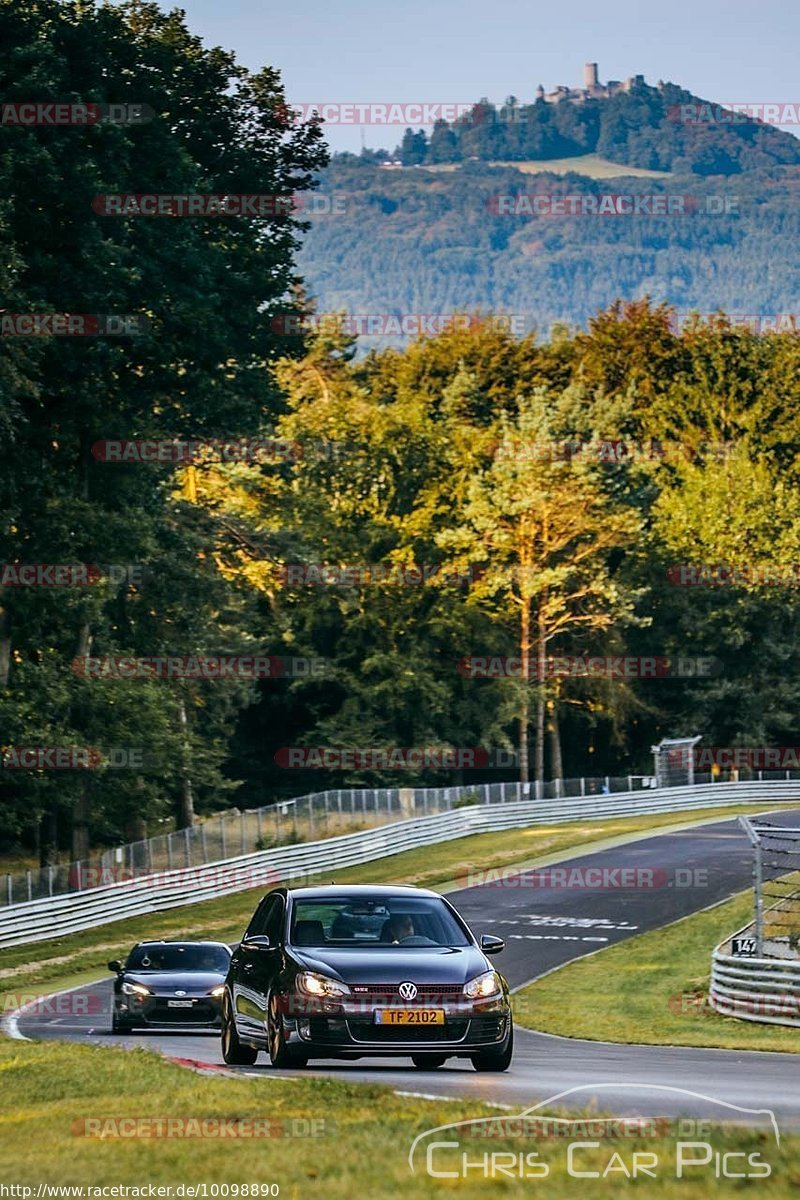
<box><xmin>439</xmin><ymin>390</ymin><xmax>639</xmax><ymax>782</ymax></box>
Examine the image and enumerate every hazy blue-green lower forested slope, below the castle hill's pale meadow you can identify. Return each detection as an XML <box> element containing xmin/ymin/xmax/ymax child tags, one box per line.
<box><xmin>299</xmin><ymin>161</ymin><xmax>800</xmax><ymax>348</ymax></box>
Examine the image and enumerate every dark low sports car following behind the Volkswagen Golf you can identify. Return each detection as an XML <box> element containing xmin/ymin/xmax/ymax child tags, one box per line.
<box><xmin>108</xmin><ymin>942</ymin><xmax>230</xmax><ymax>1033</ymax></box>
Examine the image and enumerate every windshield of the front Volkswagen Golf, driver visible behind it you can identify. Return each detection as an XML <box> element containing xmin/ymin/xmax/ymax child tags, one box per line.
<box><xmin>290</xmin><ymin>896</ymin><xmax>469</xmax><ymax>949</ymax></box>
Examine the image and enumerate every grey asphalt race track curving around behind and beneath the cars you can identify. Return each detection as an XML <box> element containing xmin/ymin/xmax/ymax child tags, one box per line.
<box><xmin>11</xmin><ymin>810</ymin><xmax>800</xmax><ymax>1129</ymax></box>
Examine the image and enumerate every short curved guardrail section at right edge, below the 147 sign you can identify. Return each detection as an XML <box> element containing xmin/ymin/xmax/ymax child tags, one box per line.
<box><xmin>709</xmin><ymin>923</ymin><xmax>800</xmax><ymax>1028</ymax></box>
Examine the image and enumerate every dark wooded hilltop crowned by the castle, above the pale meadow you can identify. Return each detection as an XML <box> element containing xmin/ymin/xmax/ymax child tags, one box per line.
<box><xmin>351</xmin><ymin>83</ymin><xmax>800</xmax><ymax>175</ymax></box>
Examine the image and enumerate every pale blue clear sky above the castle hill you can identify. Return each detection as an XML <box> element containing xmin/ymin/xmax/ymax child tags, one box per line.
<box><xmin>176</xmin><ymin>0</ymin><xmax>800</xmax><ymax>150</ymax></box>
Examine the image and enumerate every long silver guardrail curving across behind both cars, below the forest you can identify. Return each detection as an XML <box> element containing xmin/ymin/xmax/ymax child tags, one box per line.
<box><xmin>0</xmin><ymin>780</ymin><xmax>800</xmax><ymax>947</ymax></box>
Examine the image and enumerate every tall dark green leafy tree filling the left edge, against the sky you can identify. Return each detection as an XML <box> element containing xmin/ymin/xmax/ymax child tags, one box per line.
<box><xmin>0</xmin><ymin>0</ymin><xmax>326</xmax><ymax>853</ymax></box>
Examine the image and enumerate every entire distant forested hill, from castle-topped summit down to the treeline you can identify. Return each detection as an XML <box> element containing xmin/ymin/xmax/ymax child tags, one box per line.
<box><xmin>299</xmin><ymin>82</ymin><xmax>800</xmax><ymax>349</ymax></box>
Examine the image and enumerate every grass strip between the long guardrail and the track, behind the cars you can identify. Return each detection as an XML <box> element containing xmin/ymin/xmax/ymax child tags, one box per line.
<box><xmin>0</xmin><ymin>804</ymin><xmax>777</xmax><ymax>1012</ymax></box>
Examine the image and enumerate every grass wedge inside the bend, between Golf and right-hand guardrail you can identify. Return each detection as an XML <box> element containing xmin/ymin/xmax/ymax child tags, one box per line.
<box><xmin>515</xmin><ymin>892</ymin><xmax>800</xmax><ymax>1054</ymax></box>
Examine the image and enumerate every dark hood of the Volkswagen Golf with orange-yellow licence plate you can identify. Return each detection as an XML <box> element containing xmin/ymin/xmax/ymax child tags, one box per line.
<box><xmin>291</xmin><ymin>946</ymin><xmax>491</xmax><ymax>984</ymax></box>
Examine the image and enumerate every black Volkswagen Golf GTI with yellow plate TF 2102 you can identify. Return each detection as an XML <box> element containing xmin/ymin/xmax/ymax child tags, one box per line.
<box><xmin>222</xmin><ymin>886</ymin><xmax>513</xmax><ymax>1070</ymax></box>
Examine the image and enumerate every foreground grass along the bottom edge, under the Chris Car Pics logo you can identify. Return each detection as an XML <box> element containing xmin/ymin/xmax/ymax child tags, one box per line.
<box><xmin>0</xmin><ymin>1042</ymin><xmax>800</xmax><ymax>1200</ymax></box>
